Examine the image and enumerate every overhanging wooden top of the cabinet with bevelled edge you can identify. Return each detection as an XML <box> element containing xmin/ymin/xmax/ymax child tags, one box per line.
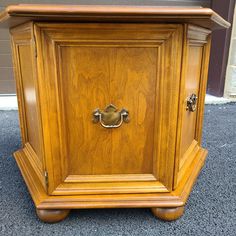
<box><xmin>0</xmin><ymin>4</ymin><xmax>230</xmax><ymax>29</ymax></box>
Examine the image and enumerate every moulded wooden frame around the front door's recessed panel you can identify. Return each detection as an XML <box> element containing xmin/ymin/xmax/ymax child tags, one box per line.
<box><xmin>34</xmin><ymin>23</ymin><xmax>183</xmax><ymax>195</ymax></box>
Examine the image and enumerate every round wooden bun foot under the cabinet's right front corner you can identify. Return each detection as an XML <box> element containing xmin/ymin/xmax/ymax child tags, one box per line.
<box><xmin>151</xmin><ymin>206</ymin><xmax>184</xmax><ymax>221</ymax></box>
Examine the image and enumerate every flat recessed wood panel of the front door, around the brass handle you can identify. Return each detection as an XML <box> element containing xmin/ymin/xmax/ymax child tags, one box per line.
<box><xmin>59</xmin><ymin>45</ymin><xmax>157</xmax><ymax>175</ymax></box>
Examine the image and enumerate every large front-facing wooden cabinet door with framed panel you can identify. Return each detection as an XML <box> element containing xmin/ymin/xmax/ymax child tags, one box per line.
<box><xmin>36</xmin><ymin>23</ymin><xmax>182</xmax><ymax>195</ymax></box>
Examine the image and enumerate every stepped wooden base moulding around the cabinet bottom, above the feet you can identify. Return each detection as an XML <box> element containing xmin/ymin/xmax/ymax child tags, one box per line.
<box><xmin>14</xmin><ymin>146</ymin><xmax>207</xmax><ymax>209</ymax></box>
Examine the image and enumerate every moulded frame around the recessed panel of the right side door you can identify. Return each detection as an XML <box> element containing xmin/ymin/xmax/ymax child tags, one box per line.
<box><xmin>173</xmin><ymin>24</ymin><xmax>211</xmax><ymax>189</ymax></box>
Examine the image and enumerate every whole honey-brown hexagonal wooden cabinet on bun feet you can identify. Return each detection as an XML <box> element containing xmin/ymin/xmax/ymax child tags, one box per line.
<box><xmin>0</xmin><ymin>5</ymin><xmax>229</xmax><ymax>222</ymax></box>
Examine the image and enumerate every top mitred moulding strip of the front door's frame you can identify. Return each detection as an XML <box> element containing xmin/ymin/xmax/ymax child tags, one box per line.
<box><xmin>37</xmin><ymin>21</ymin><xmax>180</xmax><ymax>41</ymax></box>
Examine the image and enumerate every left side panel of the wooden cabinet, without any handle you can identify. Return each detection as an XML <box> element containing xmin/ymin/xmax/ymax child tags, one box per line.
<box><xmin>10</xmin><ymin>23</ymin><xmax>44</xmax><ymax>187</ymax></box>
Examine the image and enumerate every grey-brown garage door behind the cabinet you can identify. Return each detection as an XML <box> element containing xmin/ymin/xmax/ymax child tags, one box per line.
<box><xmin>0</xmin><ymin>0</ymin><xmax>211</xmax><ymax>95</ymax></box>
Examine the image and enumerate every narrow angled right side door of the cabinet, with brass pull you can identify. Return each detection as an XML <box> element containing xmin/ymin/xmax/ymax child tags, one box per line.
<box><xmin>176</xmin><ymin>25</ymin><xmax>210</xmax><ymax>186</ymax></box>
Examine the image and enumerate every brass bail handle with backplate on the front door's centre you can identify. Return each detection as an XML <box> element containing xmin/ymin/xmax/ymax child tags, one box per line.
<box><xmin>93</xmin><ymin>104</ymin><xmax>129</xmax><ymax>128</ymax></box>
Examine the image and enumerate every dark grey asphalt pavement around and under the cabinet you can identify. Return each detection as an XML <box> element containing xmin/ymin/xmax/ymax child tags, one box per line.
<box><xmin>0</xmin><ymin>104</ymin><xmax>236</xmax><ymax>236</ymax></box>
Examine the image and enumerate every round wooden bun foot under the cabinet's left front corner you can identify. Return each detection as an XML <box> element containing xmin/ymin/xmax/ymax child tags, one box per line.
<box><xmin>36</xmin><ymin>209</ymin><xmax>70</xmax><ymax>223</ymax></box>
